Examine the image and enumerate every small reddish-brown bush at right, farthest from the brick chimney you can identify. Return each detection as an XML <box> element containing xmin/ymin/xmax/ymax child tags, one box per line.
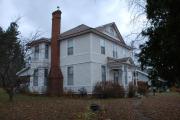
<box><xmin>137</xmin><ymin>81</ymin><xmax>148</xmax><ymax>95</ymax></box>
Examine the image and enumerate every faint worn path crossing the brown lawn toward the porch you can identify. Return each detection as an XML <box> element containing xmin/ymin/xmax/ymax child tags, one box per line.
<box><xmin>133</xmin><ymin>99</ymin><xmax>152</xmax><ymax>120</ymax></box>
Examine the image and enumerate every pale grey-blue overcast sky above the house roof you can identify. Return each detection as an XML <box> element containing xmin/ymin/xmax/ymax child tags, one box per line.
<box><xmin>0</xmin><ymin>0</ymin><xmax>144</xmax><ymax>43</ymax></box>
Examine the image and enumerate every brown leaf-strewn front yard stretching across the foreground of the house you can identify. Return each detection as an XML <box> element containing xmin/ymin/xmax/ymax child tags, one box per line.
<box><xmin>0</xmin><ymin>89</ymin><xmax>180</xmax><ymax>120</ymax></box>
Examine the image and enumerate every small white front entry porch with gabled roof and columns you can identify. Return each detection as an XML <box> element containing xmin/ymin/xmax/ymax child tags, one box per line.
<box><xmin>107</xmin><ymin>57</ymin><xmax>137</xmax><ymax>88</ymax></box>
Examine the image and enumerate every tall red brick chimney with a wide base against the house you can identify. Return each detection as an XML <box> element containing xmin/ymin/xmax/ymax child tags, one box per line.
<box><xmin>48</xmin><ymin>10</ymin><xmax>63</xmax><ymax>96</ymax></box>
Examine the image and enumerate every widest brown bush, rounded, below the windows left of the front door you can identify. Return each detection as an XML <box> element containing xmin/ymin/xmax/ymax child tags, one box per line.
<box><xmin>93</xmin><ymin>81</ymin><xmax>125</xmax><ymax>98</ymax></box>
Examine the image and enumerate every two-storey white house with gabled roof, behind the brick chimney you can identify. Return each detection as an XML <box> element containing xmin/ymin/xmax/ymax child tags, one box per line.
<box><xmin>17</xmin><ymin>9</ymin><xmax>142</xmax><ymax>93</ymax></box>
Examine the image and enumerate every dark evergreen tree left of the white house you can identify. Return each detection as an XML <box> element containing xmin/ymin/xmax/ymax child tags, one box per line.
<box><xmin>0</xmin><ymin>22</ymin><xmax>24</xmax><ymax>100</ymax></box>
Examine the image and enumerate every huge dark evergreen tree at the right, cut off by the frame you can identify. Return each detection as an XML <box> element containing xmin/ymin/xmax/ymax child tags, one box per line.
<box><xmin>139</xmin><ymin>0</ymin><xmax>180</xmax><ymax>85</ymax></box>
